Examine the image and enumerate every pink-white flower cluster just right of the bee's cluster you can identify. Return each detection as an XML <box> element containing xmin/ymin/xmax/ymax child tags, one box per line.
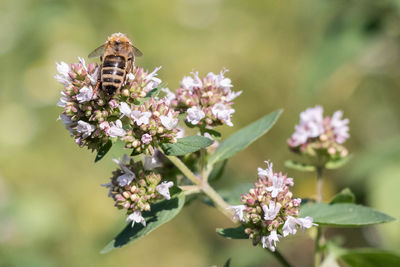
<box><xmin>172</xmin><ymin>70</ymin><xmax>242</xmax><ymax>127</ymax></box>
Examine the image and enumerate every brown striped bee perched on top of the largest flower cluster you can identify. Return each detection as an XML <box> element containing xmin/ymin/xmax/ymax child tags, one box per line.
<box><xmin>88</xmin><ymin>33</ymin><xmax>143</xmax><ymax>96</ymax></box>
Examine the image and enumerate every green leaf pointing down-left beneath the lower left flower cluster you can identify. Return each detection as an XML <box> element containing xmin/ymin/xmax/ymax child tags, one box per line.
<box><xmin>101</xmin><ymin>186</ymin><xmax>185</xmax><ymax>253</ymax></box>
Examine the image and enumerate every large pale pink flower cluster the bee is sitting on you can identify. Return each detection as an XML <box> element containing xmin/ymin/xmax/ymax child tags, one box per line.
<box><xmin>55</xmin><ymin>58</ymin><xmax>178</xmax><ymax>154</ymax></box>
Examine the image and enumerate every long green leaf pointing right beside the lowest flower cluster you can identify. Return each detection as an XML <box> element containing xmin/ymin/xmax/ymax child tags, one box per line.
<box><xmin>300</xmin><ymin>203</ymin><xmax>395</xmax><ymax>227</ymax></box>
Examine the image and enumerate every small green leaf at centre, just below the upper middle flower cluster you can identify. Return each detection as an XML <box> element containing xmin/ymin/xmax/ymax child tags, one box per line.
<box><xmin>161</xmin><ymin>135</ymin><xmax>214</xmax><ymax>156</ymax></box>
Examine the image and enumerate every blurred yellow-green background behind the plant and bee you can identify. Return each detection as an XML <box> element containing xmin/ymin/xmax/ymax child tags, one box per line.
<box><xmin>0</xmin><ymin>0</ymin><xmax>400</xmax><ymax>266</ymax></box>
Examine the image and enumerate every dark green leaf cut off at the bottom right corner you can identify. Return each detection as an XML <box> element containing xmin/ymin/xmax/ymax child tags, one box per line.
<box><xmin>340</xmin><ymin>248</ymin><xmax>400</xmax><ymax>267</ymax></box>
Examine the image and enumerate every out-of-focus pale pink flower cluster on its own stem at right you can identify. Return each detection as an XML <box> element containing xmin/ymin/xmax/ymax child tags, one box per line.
<box><xmin>288</xmin><ymin>106</ymin><xmax>350</xmax><ymax>157</ymax></box>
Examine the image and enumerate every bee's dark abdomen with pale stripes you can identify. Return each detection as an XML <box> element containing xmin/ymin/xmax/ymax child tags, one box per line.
<box><xmin>101</xmin><ymin>55</ymin><xmax>126</xmax><ymax>95</ymax></box>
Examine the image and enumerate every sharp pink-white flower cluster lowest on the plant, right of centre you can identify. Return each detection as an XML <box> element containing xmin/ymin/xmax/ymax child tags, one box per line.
<box><xmin>230</xmin><ymin>161</ymin><xmax>316</xmax><ymax>251</ymax></box>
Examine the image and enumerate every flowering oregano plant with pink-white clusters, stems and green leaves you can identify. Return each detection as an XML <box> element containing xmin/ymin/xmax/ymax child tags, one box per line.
<box><xmin>55</xmin><ymin>34</ymin><xmax>399</xmax><ymax>266</ymax></box>
